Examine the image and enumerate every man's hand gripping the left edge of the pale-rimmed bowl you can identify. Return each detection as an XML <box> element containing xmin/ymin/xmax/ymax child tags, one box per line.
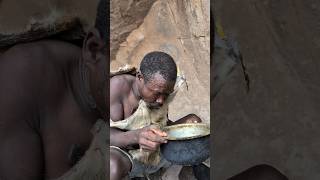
<box><xmin>137</xmin><ymin>126</ymin><xmax>167</xmax><ymax>151</ymax></box>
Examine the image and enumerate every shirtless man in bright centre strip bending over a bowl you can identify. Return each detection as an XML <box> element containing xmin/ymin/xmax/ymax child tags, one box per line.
<box><xmin>110</xmin><ymin>51</ymin><xmax>201</xmax><ymax>180</ymax></box>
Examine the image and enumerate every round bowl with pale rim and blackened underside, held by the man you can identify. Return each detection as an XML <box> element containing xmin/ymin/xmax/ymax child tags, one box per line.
<box><xmin>160</xmin><ymin>123</ymin><xmax>210</xmax><ymax>165</ymax></box>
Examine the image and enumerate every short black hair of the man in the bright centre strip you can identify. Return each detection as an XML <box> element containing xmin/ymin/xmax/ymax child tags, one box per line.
<box><xmin>140</xmin><ymin>51</ymin><xmax>177</xmax><ymax>83</ymax></box>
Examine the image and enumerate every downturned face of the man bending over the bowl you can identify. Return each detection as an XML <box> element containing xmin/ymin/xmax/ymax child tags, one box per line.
<box><xmin>140</xmin><ymin>73</ymin><xmax>175</xmax><ymax>109</ymax></box>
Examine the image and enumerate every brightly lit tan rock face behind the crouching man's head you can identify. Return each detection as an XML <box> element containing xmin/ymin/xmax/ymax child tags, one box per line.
<box><xmin>111</xmin><ymin>0</ymin><xmax>210</xmax><ymax>122</ymax></box>
